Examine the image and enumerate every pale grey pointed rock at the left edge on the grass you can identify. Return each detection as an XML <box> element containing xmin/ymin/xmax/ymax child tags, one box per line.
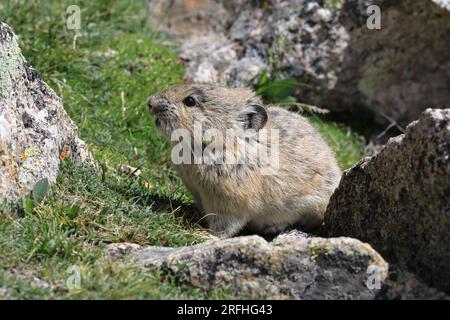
<box><xmin>0</xmin><ymin>22</ymin><xmax>90</xmax><ymax>201</ymax></box>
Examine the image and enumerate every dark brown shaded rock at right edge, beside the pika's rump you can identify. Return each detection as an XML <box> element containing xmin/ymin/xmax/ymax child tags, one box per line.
<box><xmin>325</xmin><ymin>109</ymin><xmax>450</xmax><ymax>291</ymax></box>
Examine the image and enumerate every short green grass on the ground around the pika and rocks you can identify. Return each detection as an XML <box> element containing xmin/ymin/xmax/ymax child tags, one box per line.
<box><xmin>0</xmin><ymin>0</ymin><xmax>362</xmax><ymax>299</ymax></box>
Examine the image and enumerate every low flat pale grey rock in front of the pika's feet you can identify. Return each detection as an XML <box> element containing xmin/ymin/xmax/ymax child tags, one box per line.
<box><xmin>108</xmin><ymin>234</ymin><xmax>388</xmax><ymax>299</ymax></box>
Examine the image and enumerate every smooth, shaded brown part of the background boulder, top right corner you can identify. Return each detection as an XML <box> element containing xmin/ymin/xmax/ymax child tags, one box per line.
<box><xmin>327</xmin><ymin>0</ymin><xmax>450</xmax><ymax>125</ymax></box>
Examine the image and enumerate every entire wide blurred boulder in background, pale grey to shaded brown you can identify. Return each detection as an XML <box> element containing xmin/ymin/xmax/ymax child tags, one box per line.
<box><xmin>150</xmin><ymin>0</ymin><xmax>450</xmax><ymax>124</ymax></box>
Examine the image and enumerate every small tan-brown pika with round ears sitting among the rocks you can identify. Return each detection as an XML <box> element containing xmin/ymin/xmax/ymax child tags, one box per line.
<box><xmin>147</xmin><ymin>84</ymin><xmax>341</xmax><ymax>237</ymax></box>
